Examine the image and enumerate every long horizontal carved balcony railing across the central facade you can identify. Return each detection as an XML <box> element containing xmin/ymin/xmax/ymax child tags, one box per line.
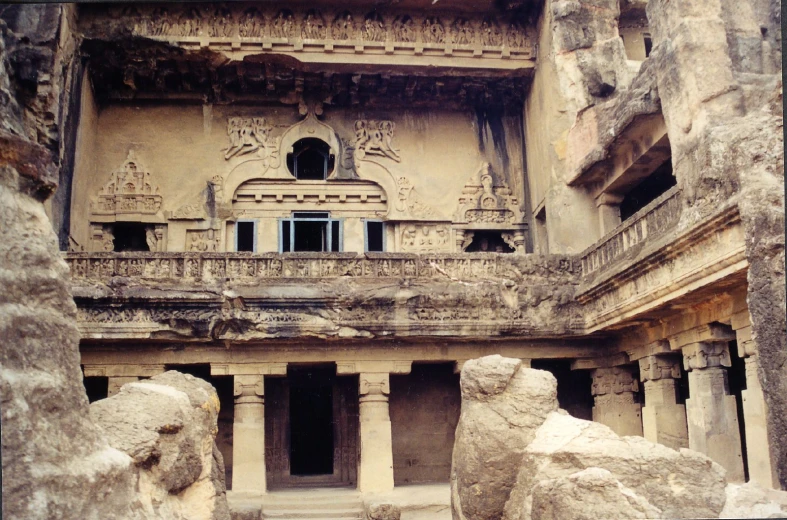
<box><xmin>65</xmin><ymin>252</ymin><xmax>577</xmax><ymax>283</ymax></box>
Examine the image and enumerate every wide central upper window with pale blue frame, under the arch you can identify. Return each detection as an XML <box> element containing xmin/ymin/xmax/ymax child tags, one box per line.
<box><xmin>279</xmin><ymin>212</ymin><xmax>342</xmax><ymax>253</ymax></box>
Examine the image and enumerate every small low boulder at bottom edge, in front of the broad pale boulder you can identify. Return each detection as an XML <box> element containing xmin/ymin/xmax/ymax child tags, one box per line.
<box><xmin>532</xmin><ymin>468</ymin><xmax>664</xmax><ymax>520</ymax></box>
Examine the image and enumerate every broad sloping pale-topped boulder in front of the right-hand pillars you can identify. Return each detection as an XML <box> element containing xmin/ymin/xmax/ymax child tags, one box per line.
<box><xmin>504</xmin><ymin>412</ymin><xmax>726</xmax><ymax>520</ymax></box>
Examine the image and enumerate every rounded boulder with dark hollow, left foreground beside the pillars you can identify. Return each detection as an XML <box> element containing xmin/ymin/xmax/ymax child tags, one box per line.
<box><xmin>90</xmin><ymin>371</ymin><xmax>230</xmax><ymax>520</ymax></box>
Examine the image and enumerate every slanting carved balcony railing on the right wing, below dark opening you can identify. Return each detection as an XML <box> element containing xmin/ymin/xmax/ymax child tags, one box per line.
<box><xmin>580</xmin><ymin>187</ymin><xmax>681</xmax><ymax>275</ymax></box>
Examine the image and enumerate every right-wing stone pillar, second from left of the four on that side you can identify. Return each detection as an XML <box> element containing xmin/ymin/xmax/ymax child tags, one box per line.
<box><xmin>639</xmin><ymin>355</ymin><xmax>689</xmax><ymax>450</ymax></box>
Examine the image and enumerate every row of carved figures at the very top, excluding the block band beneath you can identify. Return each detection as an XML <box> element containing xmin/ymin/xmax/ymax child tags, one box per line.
<box><xmin>123</xmin><ymin>5</ymin><xmax>528</xmax><ymax>48</ymax></box>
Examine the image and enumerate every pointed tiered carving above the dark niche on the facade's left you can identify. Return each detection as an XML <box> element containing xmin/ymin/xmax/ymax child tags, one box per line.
<box><xmin>92</xmin><ymin>150</ymin><xmax>163</xmax><ymax>216</ymax></box>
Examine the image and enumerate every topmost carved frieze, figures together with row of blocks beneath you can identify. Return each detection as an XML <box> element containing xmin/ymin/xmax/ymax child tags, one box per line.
<box><xmin>117</xmin><ymin>4</ymin><xmax>533</xmax><ymax>64</ymax></box>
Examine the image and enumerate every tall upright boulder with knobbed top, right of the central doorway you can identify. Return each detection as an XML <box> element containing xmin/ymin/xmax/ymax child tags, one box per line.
<box><xmin>451</xmin><ymin>355</ymin><xmax>557</xmax><ymax>520</ymax></box>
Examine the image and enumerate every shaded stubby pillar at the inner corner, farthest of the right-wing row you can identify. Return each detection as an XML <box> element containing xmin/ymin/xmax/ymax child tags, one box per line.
<box><xmin>590</xmin><ymin>366</ymin><xmax>642</xmax><ymax>436</ymax></box>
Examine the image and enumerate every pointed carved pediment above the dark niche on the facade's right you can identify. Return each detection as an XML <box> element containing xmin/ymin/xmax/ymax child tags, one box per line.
<box><xmin>454</xmin><ymin>163</ymin><xmax>523</xmax><ymax>225</ymax></box>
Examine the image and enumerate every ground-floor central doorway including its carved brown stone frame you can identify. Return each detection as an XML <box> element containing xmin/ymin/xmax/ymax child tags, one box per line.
<box><xmin>265</xmin><ymin>364</ymin><xmax>358</xmax><ymax>489</ymax></box>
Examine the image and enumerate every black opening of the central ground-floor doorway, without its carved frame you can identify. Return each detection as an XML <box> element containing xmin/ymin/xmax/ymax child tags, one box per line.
<box><xmin>289</xmin><ymin>367</ymin><xmax>335</xmax><ymax>476</ymax></box>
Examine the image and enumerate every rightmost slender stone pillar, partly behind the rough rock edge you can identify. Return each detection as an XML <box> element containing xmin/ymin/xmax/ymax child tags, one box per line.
<box><xmin>732</xmin><ymin>309</ymin><xmax>780</xmax><ymax>489</ymax></box>
